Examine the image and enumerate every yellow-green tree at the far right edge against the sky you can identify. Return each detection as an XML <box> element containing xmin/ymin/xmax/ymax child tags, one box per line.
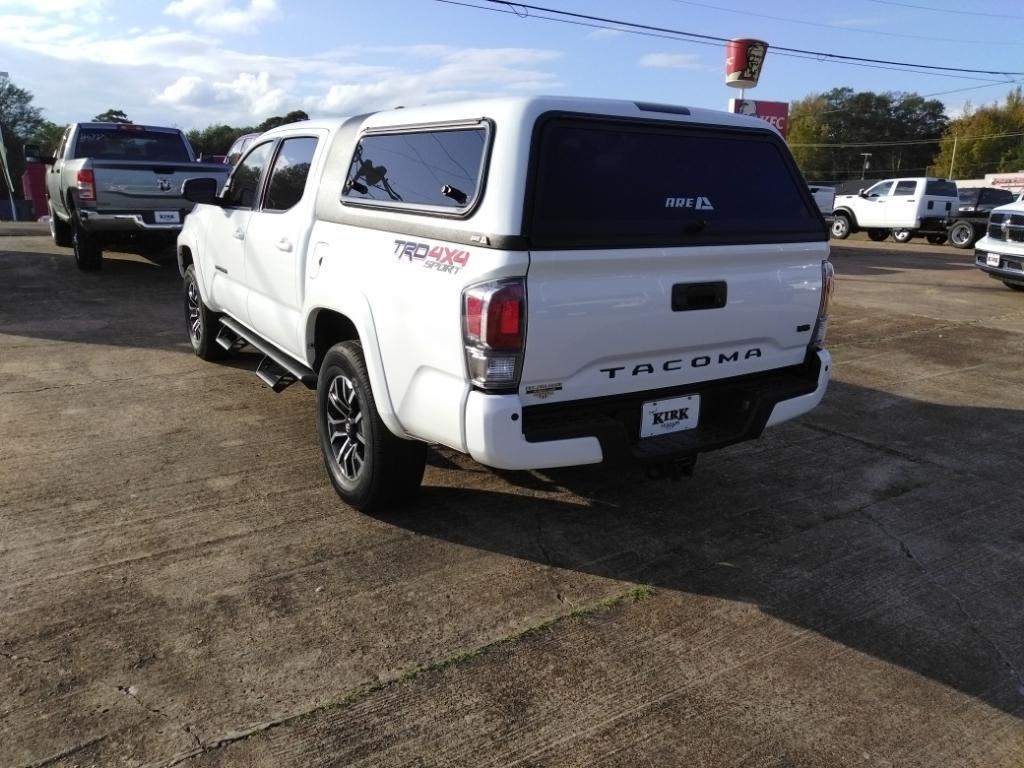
<box><xmin>933</xmin><ymin>86</ymin><xmax>1024</xmax><ymax>178</ymax></box>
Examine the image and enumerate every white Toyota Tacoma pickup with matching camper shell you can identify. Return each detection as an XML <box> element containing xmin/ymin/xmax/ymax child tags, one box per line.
<box><xmin>178</xmin><ymin>97</ymin><xmax>833</xmax><ymax>509</ymax></box>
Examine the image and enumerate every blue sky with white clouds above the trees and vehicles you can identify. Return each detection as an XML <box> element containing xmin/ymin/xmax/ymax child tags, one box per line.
<box><xmin>0</xmin><ymin>0</ymin><xmax>1024</xmax><ymax>129</ymax></box>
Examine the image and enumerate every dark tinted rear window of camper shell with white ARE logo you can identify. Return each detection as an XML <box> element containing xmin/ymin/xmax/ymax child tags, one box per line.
<box><xmin>525</xmin><ymin>115</ymin><xmax>826</xmax><ymax>249</ymax></box>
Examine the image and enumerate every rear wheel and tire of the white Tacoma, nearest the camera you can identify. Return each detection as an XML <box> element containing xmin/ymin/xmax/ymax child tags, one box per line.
<box><xmin>316</xmin><ymin>341</ymin><xmax>427</xmax><ymax>512</ymax></box>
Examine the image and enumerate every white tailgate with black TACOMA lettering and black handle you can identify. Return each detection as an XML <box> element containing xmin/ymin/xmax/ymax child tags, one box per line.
<box><xmin>520</xmin><ymin>243</ymin><xmax>828</xmax><ymax>402</ymax></box>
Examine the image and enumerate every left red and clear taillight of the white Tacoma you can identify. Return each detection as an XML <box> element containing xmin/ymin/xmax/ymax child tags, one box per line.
<box><xmin>462</xmin><ymin>278</ymin><xmax>526</xmax><ymax>389</ymax></box>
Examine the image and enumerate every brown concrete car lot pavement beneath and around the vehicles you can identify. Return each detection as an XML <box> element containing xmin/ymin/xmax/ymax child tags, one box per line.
<box><xmin>0</xmin><ymin>226</ymin><xmax>1024</xmax><ymax>768</ymax></box>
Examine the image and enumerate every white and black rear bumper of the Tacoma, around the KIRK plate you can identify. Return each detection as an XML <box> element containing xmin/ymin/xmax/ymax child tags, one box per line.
<box><xmin>466</xmin><ymin>350</ymin><xmax>831</xmax><ymax>469</ymax></box>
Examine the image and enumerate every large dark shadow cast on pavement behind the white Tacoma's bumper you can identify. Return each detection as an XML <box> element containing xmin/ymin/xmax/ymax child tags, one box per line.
<box><xmin>380</xmin><ymin>384</ymin><xmax>1024</xmax><ymax>716</ymax></box>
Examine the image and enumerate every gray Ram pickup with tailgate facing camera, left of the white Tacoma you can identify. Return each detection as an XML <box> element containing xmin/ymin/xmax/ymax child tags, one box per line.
<box><xmin>36</xmin><ymin>123</ymin><xmax>230</xmax><ymax>270</ymax></box>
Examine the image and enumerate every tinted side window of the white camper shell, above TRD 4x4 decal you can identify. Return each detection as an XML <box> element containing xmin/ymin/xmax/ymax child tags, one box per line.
<box><xmin>342</xmin><ymin>127</ymin><xmax>487</xmax><ymax>213</ymax></box>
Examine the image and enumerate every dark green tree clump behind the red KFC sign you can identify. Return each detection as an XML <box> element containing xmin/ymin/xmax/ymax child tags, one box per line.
<box><xmin>788</xmin><ymin>88</ymin><xmax>948</xmax><ymax>180</ymax></box>
